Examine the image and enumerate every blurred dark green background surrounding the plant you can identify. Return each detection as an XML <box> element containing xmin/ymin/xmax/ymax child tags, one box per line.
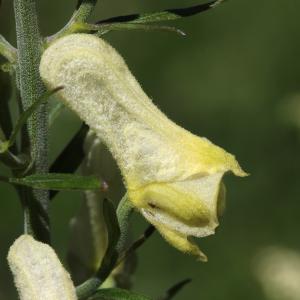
<box><xmin>0</xmin><ymin>0</ymin><xmax>300</xmax><ymax>300</ymax></box>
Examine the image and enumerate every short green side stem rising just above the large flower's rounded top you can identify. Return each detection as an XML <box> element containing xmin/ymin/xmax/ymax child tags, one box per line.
<box><xmin>47</xmin><ymin>0</ymin><xmax>98</xmax><ymax>44</ymax></box>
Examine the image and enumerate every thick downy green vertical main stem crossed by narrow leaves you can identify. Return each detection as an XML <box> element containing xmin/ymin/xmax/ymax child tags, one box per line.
<box><xmin>14</xmin><ymin>0</ymin><xmax>50</xmax><ymax>242</ymax></box>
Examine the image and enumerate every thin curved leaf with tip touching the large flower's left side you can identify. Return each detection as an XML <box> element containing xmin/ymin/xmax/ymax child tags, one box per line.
<box><xmin>9</xmin><ymin>87</ymin><xmax>63</xmax><ymax>146</ymax></box>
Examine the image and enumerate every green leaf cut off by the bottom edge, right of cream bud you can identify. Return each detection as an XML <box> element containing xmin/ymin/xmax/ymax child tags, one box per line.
<box><xmin>89</xmin><ymin>288</ymin><xmax>151</xmax><ymax>300</ymax></box>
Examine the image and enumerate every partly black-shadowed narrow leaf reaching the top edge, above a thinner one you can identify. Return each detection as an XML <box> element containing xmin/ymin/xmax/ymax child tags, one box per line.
<box><xmin>97</xmin><ymin>0</ymin><xmax>224</xmax><ymax>24</ymax></box>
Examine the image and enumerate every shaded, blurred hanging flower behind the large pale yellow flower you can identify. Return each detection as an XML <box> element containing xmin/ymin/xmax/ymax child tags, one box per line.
<box><xmin>68</xmin><ymin>130</ymin><xmax>124</xmax><ymax>283</ymax></box>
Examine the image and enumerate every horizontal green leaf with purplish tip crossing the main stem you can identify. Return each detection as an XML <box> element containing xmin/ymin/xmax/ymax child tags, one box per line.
<box><xmin>9</xmin><ymin>173</ymin><xmax>103</xmax><ymax>190</ymax></box>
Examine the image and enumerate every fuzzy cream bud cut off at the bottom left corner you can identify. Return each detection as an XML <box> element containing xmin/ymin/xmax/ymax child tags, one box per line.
<box><xmin>7</xmin><ymin>235</ymin><xmax>77</xmax><ymax>300</ymax></box>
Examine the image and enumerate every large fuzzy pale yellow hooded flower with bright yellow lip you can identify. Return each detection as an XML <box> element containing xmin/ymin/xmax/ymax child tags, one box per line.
<box><xmin>40</xmin><ymin>34</ymin><xmax>245</xmax><ymax>260</ymax></box>
